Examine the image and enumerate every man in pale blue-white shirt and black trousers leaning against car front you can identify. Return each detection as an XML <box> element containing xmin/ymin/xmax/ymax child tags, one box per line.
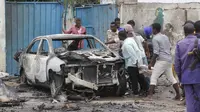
<box><xmin>119</xmin><ymin>31</ymin><xmax>145</xmax><ymax>95</ymax></box>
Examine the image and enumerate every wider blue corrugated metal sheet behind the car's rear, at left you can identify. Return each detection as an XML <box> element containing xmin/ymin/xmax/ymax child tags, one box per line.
<box><xmin>6</xmin><ymin>2</ymin><xmax>63</xmax><ymax>74</ymax></box>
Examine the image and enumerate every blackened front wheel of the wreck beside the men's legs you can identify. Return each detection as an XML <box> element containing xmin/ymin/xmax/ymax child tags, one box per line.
<box><xmin>116</xmin><ymin>68</ymin><xmax>127</xmax><ymax>96</ymax></box>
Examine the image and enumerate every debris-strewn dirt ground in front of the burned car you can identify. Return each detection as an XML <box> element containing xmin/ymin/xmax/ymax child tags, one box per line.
<box><xmin>0</xmin><ymin>77</ymin><xmax>185</xmax><ymax>112</ymax></box>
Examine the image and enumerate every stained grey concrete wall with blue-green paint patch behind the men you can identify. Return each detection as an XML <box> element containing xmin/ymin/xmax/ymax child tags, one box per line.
<box><xmin>119</xmin><ymin>2</ymin><xmax>200</xmax><ymax>59</ymax></box>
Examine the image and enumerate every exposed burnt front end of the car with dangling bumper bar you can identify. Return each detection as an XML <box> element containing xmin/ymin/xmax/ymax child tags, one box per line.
<box><xmin>65</xmin><ymin>63</ymin><xmax>122</xmax><ymax>90</ymax></box>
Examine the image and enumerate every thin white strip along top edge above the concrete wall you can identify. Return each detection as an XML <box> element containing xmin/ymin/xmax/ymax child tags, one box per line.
<box><xmin>138</xmin><ymin>0</ymin><xmax>200</xmax><ymax>3</ymax></box>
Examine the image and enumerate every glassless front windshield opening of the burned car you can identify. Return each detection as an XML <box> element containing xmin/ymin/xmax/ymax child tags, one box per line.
<box><xmin>52</xmin><ymin>37</ymin><xmax>106</xmax><ymax>54</ymax></box>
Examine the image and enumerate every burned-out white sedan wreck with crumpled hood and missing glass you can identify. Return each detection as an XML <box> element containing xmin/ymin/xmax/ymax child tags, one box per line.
<box><xmin>19</xmin><ymin>34</ymin><xmax>126</xmax><ymax>97</ymax></box>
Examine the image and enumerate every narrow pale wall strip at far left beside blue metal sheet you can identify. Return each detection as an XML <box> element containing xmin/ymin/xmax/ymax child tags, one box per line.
<box><xmin>0</xmin><ymin>0</ymin><xmax>6</xmax><ymax>71</ymax></box>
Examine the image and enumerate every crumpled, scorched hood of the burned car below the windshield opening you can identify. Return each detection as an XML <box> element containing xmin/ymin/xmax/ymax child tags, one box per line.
<box><xmin>60</xmin><ymin>49</ymin><xmax>121</xmax><ymax>62</ymax></box>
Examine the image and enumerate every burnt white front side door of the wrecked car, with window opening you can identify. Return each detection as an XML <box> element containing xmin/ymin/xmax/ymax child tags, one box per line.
<box><xmin>35</xmin><ymin>39</ymin><xmax>51</xmax><ymax>84</ymax></box>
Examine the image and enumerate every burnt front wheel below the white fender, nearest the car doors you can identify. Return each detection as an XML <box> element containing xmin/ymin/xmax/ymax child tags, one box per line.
<box><xmin>50</xmin><ymin>73</ymin><xmax>64</xmax><ymax>97</ymax></box>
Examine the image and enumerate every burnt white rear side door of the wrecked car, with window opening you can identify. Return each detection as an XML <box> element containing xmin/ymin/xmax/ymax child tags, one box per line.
<box><xmin>22</xmin><ymin>39</ymin><xmax>41</xmax><ymax>84</ymax></box>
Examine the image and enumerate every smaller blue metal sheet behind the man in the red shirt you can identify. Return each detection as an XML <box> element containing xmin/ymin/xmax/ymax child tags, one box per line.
<box><xmin>76</xmin><ymin>4</ymin><xmax>118</xmax><ymax>41</ymax></box>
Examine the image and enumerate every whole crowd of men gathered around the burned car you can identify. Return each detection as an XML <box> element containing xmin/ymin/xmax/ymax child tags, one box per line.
<box><xmin>63</xmin><ymin>18</ymin><xmax>200</xmax><ymax>112</ymax></box>
